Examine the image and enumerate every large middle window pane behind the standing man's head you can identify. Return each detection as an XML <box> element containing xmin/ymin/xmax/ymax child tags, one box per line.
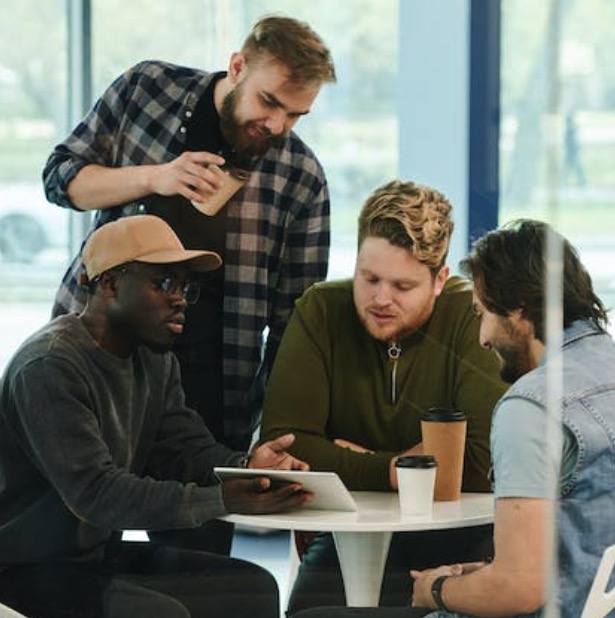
<box><xmin>93</xmin><ymin>0</ymin><xmax>399</xmax><ymax>278</ymax></box>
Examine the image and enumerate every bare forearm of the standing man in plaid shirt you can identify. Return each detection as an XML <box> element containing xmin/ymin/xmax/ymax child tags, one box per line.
<box><xmin>68</xmin><ymin>164</ymin><xmax>157</xmax><ymax>210</ymax></box>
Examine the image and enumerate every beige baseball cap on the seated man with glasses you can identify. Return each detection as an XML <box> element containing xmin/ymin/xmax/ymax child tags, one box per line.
<box><xmin>81</xmin><ymin>215</ymin><xmax>222</xmax><ymax>281</ymax></box>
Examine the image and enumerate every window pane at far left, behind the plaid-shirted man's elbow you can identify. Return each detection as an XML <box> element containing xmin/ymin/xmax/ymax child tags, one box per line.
<box><xmin>0</xmin><ymin>0</ymin><xmax>69</xmax><ymax>369</ymax></box>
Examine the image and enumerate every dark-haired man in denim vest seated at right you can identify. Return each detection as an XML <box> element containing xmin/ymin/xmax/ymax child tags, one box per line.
<box><xmin>301</xmin><ymin>220</ymin><xmax>615</xmax><ymax>618</ymax></box>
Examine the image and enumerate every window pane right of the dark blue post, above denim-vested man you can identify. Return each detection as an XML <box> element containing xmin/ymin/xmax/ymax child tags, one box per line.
<box><xmin>500</xmin><ymin>0</ymin><xmax>615</xmax><ymax>328</ymax></box>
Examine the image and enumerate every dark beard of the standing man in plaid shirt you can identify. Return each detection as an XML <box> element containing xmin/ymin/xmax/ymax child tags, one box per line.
<box><xmin>220</xmin><ymin>86</ymin><xmax>286</xmax><ymax>160</ymax></box>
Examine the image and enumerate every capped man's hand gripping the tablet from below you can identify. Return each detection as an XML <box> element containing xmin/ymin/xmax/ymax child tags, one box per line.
<box><xmin>222</xmin><ymin>477</ymin><xmax>314</xmax><ymax>515</ymax></box>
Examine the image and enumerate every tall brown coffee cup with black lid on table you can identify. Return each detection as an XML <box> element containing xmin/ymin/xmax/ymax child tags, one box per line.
<box><xmin>421</xmin><ymin>408</ymin><xmax>468</xmax><ymax>501</ymax></box>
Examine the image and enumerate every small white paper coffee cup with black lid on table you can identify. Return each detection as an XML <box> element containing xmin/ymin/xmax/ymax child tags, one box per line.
<box><xmin>395</xmin><ymin>455</ymin><xmax>437</xmax><ymax>516</ymax></box>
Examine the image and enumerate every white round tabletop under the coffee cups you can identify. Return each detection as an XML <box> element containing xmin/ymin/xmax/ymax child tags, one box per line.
<box><xmin>221</xmin><ymin>491</ymin><xmax>494</xmax><ymax>532</ymax></box>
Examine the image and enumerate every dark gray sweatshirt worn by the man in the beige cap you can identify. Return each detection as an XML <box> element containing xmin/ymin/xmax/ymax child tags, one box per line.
<box><xmin>0</xmin><ymin>315</ymin><xmax>243</xmax><ymax>566</ymax></box>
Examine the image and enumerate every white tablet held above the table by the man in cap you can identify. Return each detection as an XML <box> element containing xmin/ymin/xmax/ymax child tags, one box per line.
<box><xmin>214</xmin><ymin>468</ymin><xmax>357</xmax><ymax>511</ymax></box>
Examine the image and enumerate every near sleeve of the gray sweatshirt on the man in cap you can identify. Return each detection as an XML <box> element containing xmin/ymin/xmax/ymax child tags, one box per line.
<box><xmin>5</xmin><ymin>357</ymin><xmax>231</xmax><ymax>530</ymax></box>
